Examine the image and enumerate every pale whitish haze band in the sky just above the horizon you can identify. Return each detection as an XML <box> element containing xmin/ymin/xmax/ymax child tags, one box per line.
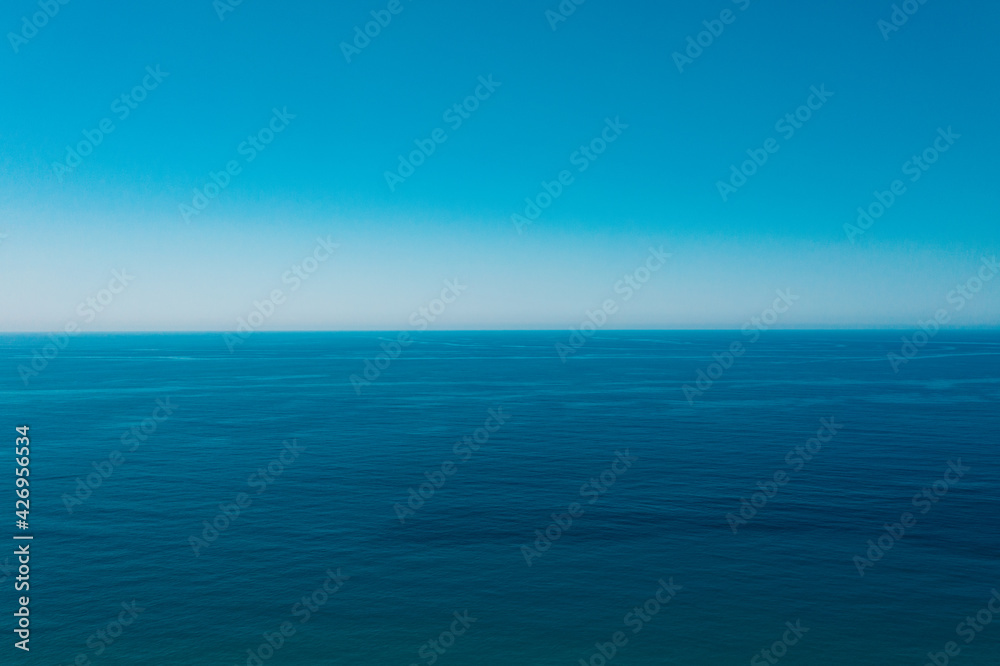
<box><xmin>0</xmin><ymin>215</ymin><xmax>1000</xmax><ymax>332</ymax></box>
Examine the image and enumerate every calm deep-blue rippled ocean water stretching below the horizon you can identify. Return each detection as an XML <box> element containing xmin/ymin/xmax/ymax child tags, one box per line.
<box><xmin>0</xmin><ymin>331</ymin><xmax>1000</xmax><ymax>666</ymax></box>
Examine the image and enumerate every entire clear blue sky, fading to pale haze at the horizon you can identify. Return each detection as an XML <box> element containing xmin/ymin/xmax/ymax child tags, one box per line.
<box><xmin>0</xmin><ymin>0</ymin><xmax>1000</xmax><ymax>332</ymax></box>
